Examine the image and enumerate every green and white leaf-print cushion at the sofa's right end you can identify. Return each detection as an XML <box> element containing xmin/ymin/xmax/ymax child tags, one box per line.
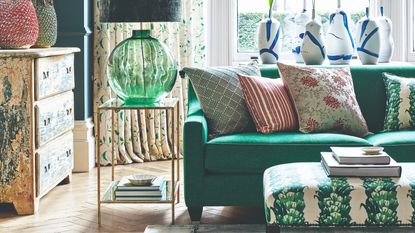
<box><xmin>383</xmin><ymin>73</ymin><xmax>415</xmax><ymax>131</ymax></box>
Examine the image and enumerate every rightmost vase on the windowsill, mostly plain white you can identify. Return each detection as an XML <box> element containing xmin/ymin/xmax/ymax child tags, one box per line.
<box><xmin>378</xmin><ymin>6</ymin><xmax>395</xmax><ymax>63</ymax></box>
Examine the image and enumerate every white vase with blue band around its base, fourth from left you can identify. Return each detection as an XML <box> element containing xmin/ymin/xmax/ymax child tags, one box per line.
<box><xmin>326</xmin><ymin>0</ymin><xmax>355</xmax><ymax>65</ymax></box>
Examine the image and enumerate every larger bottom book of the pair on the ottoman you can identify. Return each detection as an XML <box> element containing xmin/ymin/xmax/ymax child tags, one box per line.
<box><xmin>321</xmin><ymin>152</ymin><xmax>402</xmax><ymax>177</ymax></box>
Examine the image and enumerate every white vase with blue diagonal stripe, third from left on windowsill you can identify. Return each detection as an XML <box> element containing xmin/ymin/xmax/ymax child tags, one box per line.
<box><xmin>301</xmin><ymin>3</ymin><xmax>326</xmax><ymax>65</ymax></box>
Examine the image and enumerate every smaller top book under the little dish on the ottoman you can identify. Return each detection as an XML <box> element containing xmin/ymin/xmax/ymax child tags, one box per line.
<box><xmin>330</xmin><ymin>147</ymin><xmax>391</xmax><ymax>164</ymax></box>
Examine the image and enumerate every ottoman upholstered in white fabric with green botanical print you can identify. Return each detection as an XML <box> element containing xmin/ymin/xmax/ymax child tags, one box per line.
<box><xmin>264</xmin><ymin>163</ymin><xmax>415</xmax><ymax>232</ymax></box>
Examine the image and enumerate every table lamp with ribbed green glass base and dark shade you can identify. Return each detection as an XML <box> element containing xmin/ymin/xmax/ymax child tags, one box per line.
<box><xmin>100</xmin><ymin>0</ymin><xmax>182</xmax><ymax>103</ymax></box>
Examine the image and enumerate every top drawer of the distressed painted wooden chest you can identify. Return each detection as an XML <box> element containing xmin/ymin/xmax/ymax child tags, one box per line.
<box><xmin>35</xmin><ymin>54</ymin><xmax>75</xmax><ymax>100</ymax></box>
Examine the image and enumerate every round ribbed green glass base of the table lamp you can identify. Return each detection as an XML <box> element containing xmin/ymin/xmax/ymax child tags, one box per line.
<box><xmin>108</xmin><ymin>30</ymin><xmax>177</xmax><ymax>103</ymax></box>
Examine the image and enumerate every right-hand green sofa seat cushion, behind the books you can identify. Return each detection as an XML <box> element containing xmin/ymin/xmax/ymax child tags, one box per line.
<box><xmin>365</xmin><ymin>130</ymin><xmax>415</xmax><ymax>162</ymax></box>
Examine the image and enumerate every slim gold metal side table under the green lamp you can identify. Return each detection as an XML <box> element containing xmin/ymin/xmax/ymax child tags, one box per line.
<box><xmin>96</xmin><ymin>98</ymin><xmax>180</xmax><ymax>225</ymax></box>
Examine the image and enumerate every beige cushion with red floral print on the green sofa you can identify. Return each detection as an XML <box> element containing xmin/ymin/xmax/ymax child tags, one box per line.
<box><xmin>278</xmin><ymin>63</ymin><xmax>369</xmax><ymax>137</ymax></box>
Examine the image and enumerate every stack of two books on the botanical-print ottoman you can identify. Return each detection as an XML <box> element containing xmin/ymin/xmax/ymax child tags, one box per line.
<box><xmin>321</xmin><ymin>147</ymin><xmax>402</xmax><ymax>177</ymax></box>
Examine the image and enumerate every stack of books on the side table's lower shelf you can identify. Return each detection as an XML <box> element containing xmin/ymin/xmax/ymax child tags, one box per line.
<box><xmin>114</xmin><ymin>177</ymin><xmax>170</xmax><ymax>201</ymax></box>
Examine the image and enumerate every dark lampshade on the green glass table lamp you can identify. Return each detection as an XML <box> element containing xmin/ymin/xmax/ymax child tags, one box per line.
<box><xmin>100</xmin><ymin>0</ymin><xmax>182</xmax><ymax>23</ymax></box>
